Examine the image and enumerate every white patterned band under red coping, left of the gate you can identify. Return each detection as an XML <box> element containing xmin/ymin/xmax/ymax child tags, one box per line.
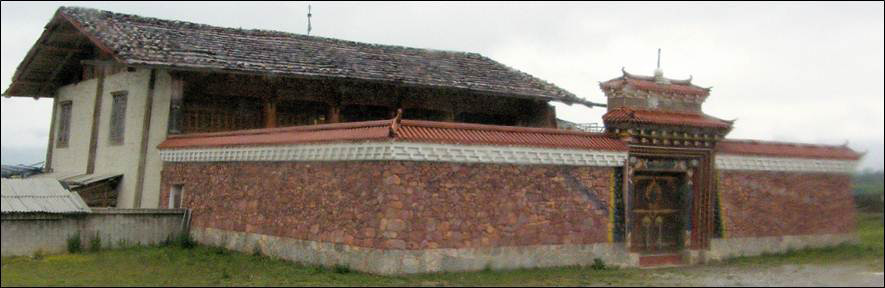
<box><xmin>160</xmin><ymin>142</ymin><xmax>627</xmax><ymax>167</ymax></box>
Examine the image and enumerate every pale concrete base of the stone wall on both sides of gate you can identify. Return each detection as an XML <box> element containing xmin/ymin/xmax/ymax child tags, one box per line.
<box><xmin>191</xmin><ymin>227</ymin><xmax>857</xmax><ymax>275</ymax></box>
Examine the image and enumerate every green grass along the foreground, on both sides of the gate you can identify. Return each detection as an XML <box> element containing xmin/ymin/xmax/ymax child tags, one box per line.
<box><xmin>0</xmin><ymin>214</ymin><xmax>883</xmax><ymax>287</ymax></box>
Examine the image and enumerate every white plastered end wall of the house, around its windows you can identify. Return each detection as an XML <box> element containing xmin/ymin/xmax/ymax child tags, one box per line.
<box><xmin>52</xmin><ymin>68</ymin><xmax>171</xmax><ymax>208</ymax></box>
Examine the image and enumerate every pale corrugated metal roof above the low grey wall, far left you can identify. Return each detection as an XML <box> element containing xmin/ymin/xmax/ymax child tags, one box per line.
<box><xmin>0</xmin><ymin>178</ymin><xmax>92</xmax><ymax>213</ymax></box>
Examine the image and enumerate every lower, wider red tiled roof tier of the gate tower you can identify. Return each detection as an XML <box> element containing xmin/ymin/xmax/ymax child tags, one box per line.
<box><xmin>602</xmin><ymin>107</ymin><xmax>732</xmax><ymax>129</ymax></box>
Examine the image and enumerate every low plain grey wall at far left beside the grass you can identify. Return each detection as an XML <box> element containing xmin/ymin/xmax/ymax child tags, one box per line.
<box><xmin>2</xmin><ymin>208</ymin><xmax>185</xmax><ymax>257</ymax></box>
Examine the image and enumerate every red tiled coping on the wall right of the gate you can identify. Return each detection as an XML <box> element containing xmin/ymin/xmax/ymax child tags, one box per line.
<box><xmin>716</xmin><ymin>139</ymin><xmax>863</xmax><ymax>160</ymax></box>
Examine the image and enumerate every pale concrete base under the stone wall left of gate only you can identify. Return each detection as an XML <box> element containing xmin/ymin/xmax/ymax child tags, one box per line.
<box><xmin>191</xmin><ymin>227</ymin><xmax>639</xmax><ymax>275</ymax></box>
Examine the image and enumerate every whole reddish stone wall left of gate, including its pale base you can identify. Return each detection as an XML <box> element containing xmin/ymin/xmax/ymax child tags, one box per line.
<box><xmin>161</xmin><ymin>161</ymin><xmax>620</xmax><ymax>274</ymax></box>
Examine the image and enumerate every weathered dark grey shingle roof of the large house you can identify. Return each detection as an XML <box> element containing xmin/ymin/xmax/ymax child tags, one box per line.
<box><xmin>6</xmin><ymin>7</ymin><xmax>584</xmax><ymax>104</ymax></box>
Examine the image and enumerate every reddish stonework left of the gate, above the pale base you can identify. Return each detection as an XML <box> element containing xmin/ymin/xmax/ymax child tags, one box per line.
<box><xmin>161</xmin><ymin>161</ymin><xmax>613</xmax><ymax>250</ymax></box>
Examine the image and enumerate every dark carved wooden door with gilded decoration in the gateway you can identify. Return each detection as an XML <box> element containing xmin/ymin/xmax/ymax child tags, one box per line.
<box><xmin>630</xmin><ymin>174</ymin><xmax>683</xmax><ymax>254</ymax></box>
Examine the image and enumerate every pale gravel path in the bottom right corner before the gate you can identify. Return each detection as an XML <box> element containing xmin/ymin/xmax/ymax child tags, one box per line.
<box><xmin>649</xmin><ymin>264</ymin><xmax>885</xmax><ymax>287</ymax></box>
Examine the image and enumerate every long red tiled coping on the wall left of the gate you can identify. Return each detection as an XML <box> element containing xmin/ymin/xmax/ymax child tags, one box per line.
<box><xmin>158</xmin><ymin>119</ymin><xmax>627</xmax><ymax>151</ymax></box>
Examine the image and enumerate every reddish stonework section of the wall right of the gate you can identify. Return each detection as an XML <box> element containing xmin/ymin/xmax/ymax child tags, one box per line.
<box><xmin>718</xmin><ymin>170</ymin><xmax>856</xmax><ymax>238</ymax></box>
